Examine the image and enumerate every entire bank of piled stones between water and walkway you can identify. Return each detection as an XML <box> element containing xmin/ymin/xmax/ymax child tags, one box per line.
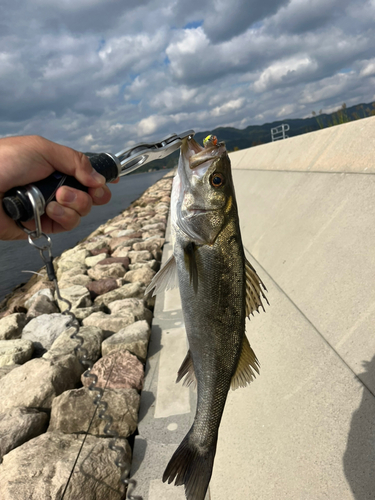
<box><xmin>0</xmin><ymin>174</ymin><xmax>172</xmax><ymax>500</ymax></box>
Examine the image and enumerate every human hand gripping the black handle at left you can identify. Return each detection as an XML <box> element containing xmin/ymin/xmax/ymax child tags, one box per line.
<box><xmin>0</xmin><ymin>136</ymin><xmax>119</xmax><ymax>240</ymax></box>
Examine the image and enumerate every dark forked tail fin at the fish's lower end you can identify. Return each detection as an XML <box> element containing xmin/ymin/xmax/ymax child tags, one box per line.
<box><xmin>163</xmin><ymin>432</ymin><xmax>216</xmax><ymax>500</ymax></box>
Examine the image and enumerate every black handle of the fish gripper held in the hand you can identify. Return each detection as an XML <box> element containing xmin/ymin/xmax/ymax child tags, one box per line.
<box><xmin>3</xmin><ymin>153</ymin><xmax>119</xmax><ymax>222</ymax></box>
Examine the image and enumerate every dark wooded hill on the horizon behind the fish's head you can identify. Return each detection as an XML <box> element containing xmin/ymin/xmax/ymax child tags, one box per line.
<box><xmin>135</xmin><ymin>101</ymin><xmax>375</xmax><ymax>173</ymax></box>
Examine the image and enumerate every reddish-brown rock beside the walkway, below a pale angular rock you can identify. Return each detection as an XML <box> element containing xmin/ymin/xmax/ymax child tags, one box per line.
<box><xmin>81</xmin><ymin>351</ymin><xmax>144</xmax><ymax>391</ymax></box>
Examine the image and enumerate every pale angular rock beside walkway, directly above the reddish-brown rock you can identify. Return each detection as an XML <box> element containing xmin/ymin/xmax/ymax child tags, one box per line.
<box><xmin>102</xmin><ymin>321</ymin><xmax>151</xmax><ymax>362</ymax></box>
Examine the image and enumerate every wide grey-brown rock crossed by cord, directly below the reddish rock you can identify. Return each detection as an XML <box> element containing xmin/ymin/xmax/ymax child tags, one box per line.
<box><xmin>48</xmin><ymin>387</ymin><xmax>140</xmax><ymax>438</ymax></box>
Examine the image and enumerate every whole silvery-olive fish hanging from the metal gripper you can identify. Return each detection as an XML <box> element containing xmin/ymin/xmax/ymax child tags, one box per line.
<box><xmin>146</xmin><ymin>136</ymin><xmax>268</xmax><ymax>500</ymax></box>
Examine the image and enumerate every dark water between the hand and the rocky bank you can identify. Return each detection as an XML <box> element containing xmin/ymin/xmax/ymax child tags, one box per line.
<box><xmin>0</xmin><ymin>170</ymin><xmax>166</xmax><ymax>301</ymax></box>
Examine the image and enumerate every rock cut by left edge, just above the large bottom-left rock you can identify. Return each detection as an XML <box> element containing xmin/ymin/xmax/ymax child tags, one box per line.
<box><xmin>0</xmin><ymin>408</ymin><xmax>48</xmax><ymax>462</ymax></box>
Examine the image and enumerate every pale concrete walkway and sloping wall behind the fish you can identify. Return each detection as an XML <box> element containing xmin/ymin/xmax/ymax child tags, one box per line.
<box><xmin>133</xmin><ymin>118</ymin><xmax>375</xmax><ymax>500</ymax></box>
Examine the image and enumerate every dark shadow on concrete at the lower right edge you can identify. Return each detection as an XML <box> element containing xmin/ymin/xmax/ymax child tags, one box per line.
<box><xmin>343</xmin><ymin>356</ymin><xmax>375</xmax><ymax>500</ymax></box>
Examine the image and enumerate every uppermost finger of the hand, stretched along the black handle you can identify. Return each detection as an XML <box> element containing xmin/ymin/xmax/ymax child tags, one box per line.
<box><xmin>33</xmin><ymin>136</ymin><xmax>106</xmax><ymax>187</ymax></box>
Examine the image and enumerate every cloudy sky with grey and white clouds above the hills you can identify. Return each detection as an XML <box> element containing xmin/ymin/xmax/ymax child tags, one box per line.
<box><xmin>0</xmin><ymin>0</ymin><xmax>375</xmax><ymax>152</ymax></box>
